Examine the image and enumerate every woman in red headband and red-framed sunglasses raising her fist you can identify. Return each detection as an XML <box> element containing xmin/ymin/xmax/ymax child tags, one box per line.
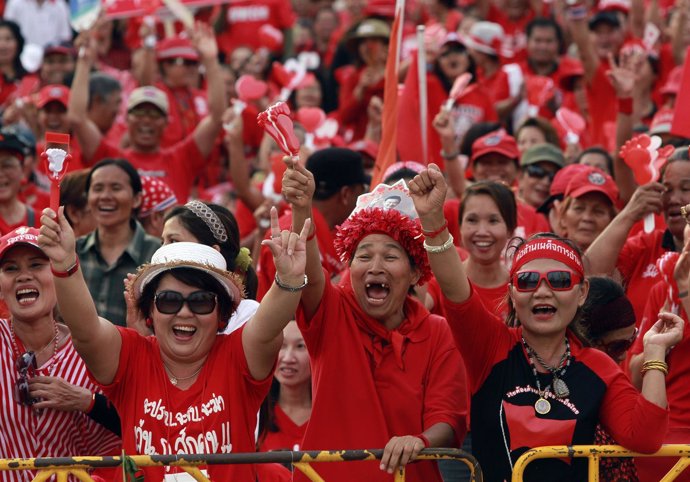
<box><xmin>410</xmin><ymin>165</ymin><xmax>683</xmax><ymax>482</ymax></box>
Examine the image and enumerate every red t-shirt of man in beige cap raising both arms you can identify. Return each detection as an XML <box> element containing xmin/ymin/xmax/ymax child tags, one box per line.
<box><xmin>93</xmin><ymin>136</ymin><xmax>206</xmax><ymax>204</ymax></box>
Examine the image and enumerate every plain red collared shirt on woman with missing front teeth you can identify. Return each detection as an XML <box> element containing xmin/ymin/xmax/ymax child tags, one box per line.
<box><xmin>295</xmin><ymin>273</ymin><xmax>467</xmax><ymax>482</ymax></box>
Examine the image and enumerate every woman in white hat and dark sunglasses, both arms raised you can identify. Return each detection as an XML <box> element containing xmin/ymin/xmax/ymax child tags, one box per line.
<box><xmin>39</xmin><ymin>205</ymin><xmax>309</xmax><ymax>480</ymax></box>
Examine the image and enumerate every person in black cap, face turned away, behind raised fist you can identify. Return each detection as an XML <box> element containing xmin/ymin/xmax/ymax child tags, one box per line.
<box><xmin>256</xmin><ymin>147</ymin><xmax>371</xmax><ymax>300</ymax></box>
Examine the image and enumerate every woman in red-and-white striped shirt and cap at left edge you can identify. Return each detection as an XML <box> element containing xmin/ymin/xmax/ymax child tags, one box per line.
<box><xmin>0</xmin><ymin>226</ymin><xmax>120</xmax><ymax>481</ymax></box>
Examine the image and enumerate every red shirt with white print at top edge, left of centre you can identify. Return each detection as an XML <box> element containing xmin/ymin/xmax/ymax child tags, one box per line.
<box><xmin>218</xmin><ymin>0</ymin><xmax>296</xmax><ymax>55</ymax></box>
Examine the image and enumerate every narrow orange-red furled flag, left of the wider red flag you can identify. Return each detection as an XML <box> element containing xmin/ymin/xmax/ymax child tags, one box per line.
<box><xmin>371</xmin><ymin>0</ymin><xmax>404</xmax><ymax>186</ymax></box>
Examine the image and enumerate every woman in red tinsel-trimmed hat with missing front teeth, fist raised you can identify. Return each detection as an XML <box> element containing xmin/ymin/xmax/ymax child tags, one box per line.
<box><xmin>280</xmin><ymin>166</ymin><xmax>467</xmax><ymax>482</ymax></box>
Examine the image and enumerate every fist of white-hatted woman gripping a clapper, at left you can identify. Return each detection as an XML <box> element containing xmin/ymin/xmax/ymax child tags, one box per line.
<box><xmin>38</xmin><ymin>206</ymin><xmax>77</xmax><ymax>271</ymax></box>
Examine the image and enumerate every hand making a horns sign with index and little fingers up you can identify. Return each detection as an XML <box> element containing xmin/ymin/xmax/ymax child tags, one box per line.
<box><xmin>261</xmin><ymin>207</ymin><xmax>311</xmax><ymax>286</ymax></box>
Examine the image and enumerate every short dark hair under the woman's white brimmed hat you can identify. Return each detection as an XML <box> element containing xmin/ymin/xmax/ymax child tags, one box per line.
<box><xmin>137</xmin><ymin>268</ymin><xmax>233</xmax><ymax>331</ymax></box>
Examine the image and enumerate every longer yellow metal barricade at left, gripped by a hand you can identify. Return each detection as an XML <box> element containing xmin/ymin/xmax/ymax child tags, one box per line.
<box><xmin>0</xmin><ymin>449</ymin><xmax>482</xmax><ymax>482</ymax></box>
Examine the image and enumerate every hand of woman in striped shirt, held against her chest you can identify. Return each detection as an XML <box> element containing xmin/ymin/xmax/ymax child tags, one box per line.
<box><xmin>29</xmin><ymin>377</ymin><xmax>93</xmax><ymax>412</ymax></box>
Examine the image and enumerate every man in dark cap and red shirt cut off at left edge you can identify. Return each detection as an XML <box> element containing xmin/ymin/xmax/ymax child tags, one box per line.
<box><xmin>0</xmin><ymin>128</ymin><xmax>40</xmax><ymax>235</ymax></box>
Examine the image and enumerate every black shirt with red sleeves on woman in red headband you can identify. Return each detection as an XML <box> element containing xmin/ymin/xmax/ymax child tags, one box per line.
<box><xmin>443</xmin><ymin>291</ymin><xmax>668</xmax><ymax>481</ymax></box>
